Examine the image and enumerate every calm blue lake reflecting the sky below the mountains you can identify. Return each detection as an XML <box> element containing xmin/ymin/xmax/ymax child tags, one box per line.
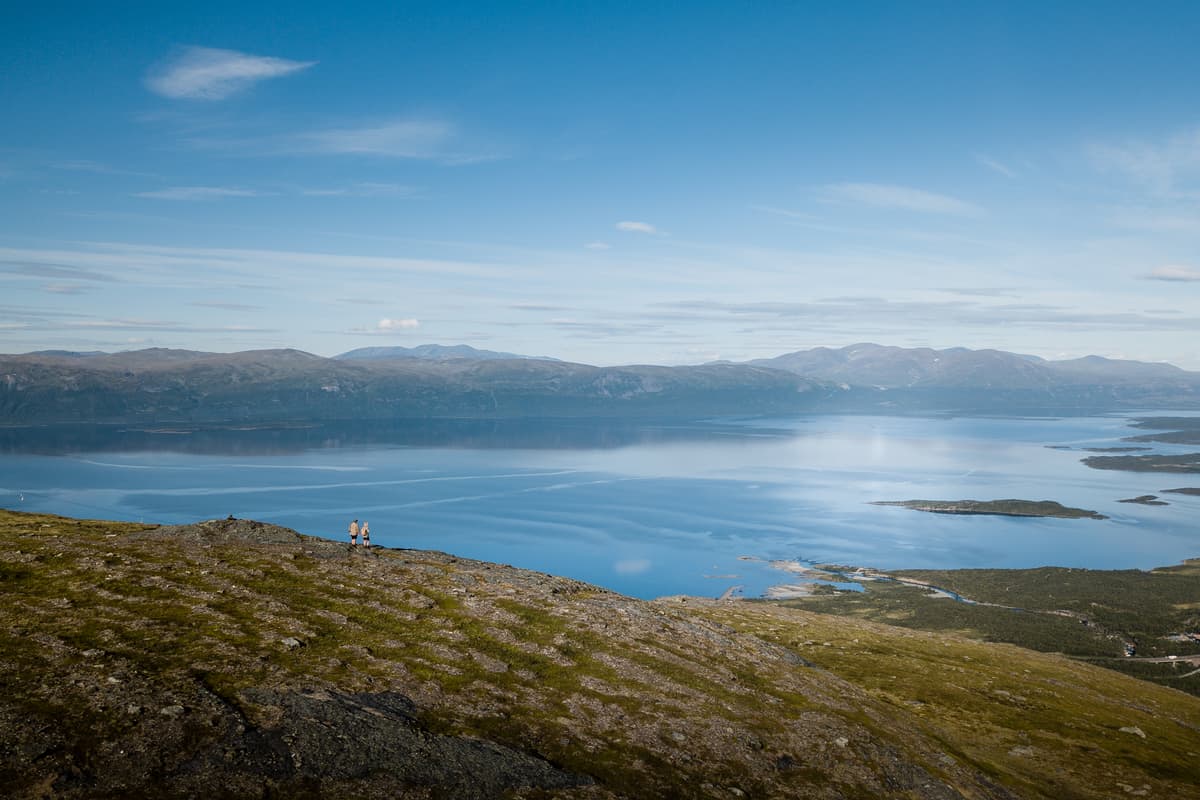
<box><xmin>0</xmin><ymin>413</ymin><xmax>1200</xmax><ymax>597</ymax></box>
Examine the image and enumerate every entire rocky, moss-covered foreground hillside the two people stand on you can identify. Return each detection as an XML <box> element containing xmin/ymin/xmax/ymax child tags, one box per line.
<box><xmin>0</xmin><ymin>512</ymin><xmax>1200</xmax><ymax>799</ymax></box>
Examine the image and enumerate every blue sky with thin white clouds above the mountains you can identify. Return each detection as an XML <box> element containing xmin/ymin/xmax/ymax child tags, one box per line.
<box><xmin>0</xmin><ymin>1</ymin><xmax>1200</xmax><ymax>369</ymax></box>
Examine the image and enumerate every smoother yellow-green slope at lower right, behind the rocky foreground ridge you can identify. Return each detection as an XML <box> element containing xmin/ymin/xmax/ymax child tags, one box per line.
<box><xmin>691</xmin><ymin>603</ymin><xmax>1200</xmax><ymax>798</ymax></box>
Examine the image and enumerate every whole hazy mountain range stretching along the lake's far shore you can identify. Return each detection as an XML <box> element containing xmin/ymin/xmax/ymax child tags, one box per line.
<box><xmin>0</xmin><ymin>344</ymin><xmax>1200</xmax><ymax>425</ymax></box>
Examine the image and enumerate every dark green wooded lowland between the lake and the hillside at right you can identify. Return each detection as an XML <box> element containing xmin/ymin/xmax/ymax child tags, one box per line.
<box><xmin>782</xmin><ymin>559</ymin><xmax>1200</xmax><ymax>694</ymax></box>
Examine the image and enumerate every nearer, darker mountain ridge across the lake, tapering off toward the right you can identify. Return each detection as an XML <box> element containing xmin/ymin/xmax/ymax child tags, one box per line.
<box><xmin>0</xmin><ymin>350</ymin><xmax>850</xmax><ymax>423</ymax></box>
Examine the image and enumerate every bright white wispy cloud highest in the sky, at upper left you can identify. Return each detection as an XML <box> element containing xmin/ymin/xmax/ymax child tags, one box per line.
<box><xmin>145</xmin><ymin>47</ymin><xmax>317</xmax><ymax>100</ymax></box>
